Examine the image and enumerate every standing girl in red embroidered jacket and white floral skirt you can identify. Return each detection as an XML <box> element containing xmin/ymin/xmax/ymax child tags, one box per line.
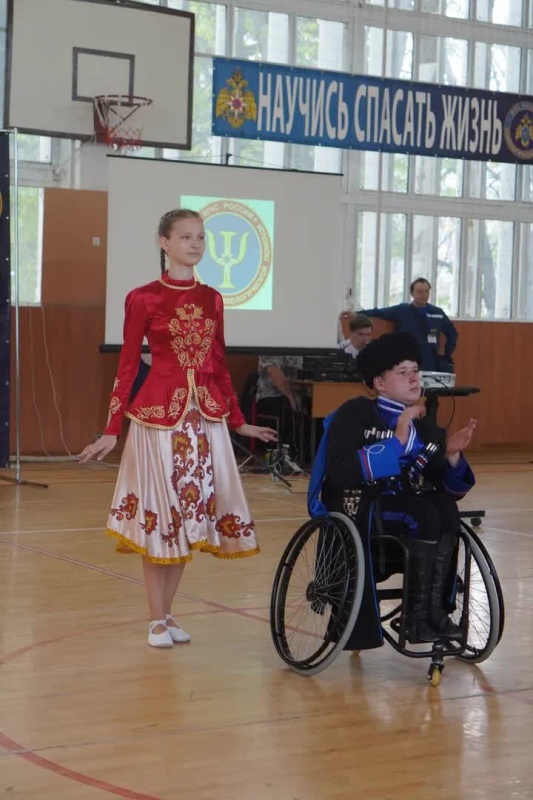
<box><xmin>79</xmin><ymin>209</ymin><xmax>276</xmax><ymax>647</ymax></box>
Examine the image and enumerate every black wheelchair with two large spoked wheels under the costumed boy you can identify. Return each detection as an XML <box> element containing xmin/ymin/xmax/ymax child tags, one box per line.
<box><xmin>270</xmin><ymin>512</ymin><xmax>505</xmax><ymax>686</ymax></box>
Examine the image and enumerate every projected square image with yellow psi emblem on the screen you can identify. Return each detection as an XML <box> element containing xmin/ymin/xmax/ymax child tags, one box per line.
<box><xmin>181</xmin><ymin>197</ymin><xmax>274</xmax><ymax>310</ymax></box>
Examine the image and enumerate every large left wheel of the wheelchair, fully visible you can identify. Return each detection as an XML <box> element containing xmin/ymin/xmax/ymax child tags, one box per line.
<box><xmin>270</xmin><ymin>514</ymin><xmax>365</xmax><ymax>675</ymax></box>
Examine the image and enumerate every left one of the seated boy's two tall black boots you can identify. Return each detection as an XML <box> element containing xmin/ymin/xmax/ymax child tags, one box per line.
<box><xmin>405</xmin><ymin>541</ymin><xmax>439</xmax><ymax>644</ymax></box>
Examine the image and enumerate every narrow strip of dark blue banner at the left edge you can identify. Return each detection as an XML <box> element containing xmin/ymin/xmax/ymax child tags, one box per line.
<box><xmin>0</xmin><ymin>133</ymin><xmax>11</xmax><ymax>467</ymax></box>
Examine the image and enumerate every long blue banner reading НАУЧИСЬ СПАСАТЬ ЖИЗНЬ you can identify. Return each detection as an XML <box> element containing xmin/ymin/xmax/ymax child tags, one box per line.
<box><xmin>213</xmin><ymin>58</ymin><xmax>533</xmax><ymax>164</ymax></box>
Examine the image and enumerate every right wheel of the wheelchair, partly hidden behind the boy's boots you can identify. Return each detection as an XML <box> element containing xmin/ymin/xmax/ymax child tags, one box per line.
<box><xmin>451</xmin><ymin>529</ymin><xmax>503</xmax><ymax>664</ymax></box>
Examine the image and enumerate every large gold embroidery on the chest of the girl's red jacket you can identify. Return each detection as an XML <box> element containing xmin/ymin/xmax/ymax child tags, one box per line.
<box><xmin>168</xmin><ymin>303</ymin><xmax>216</xmax><ymax>369</ymax></box>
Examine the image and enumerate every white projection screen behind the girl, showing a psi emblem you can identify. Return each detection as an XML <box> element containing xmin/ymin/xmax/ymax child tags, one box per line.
<box><xmin>105</xmin><ymin>156</ymin><xmax>342</xmax><ymax>349</ymax></box>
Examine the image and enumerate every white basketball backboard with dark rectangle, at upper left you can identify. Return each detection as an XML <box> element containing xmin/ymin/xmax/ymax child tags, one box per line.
<box><xmin>4</xmin><ymin>0</ymin><xmax>194</xmax><ymax>149</ymax></box>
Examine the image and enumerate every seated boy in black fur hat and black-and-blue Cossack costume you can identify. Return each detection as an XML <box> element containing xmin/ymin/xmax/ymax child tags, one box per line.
<box><xmin>321</xmin><ymin>333</ymin><xmax>476</xmax><ymax>650</ymax></box>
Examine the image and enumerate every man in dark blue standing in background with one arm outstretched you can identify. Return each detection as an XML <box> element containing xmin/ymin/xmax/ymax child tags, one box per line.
<box><xmin>360</xmin><ymin>278</ymin><xmax>457</xmax><ymax>372</ymax></box>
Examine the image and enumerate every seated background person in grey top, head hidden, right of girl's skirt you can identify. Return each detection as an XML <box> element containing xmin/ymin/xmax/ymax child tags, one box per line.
<box><xmin>255</xmin><ymin>356</ymin><xmax>303</xmax><ymax>474</ymax></box>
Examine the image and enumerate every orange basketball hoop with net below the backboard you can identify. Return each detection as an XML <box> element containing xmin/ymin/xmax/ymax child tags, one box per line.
<box><xmin>93</xmin><ymin>94</ymin><xmax>152</xmax><ymax>150</ymax></box>
